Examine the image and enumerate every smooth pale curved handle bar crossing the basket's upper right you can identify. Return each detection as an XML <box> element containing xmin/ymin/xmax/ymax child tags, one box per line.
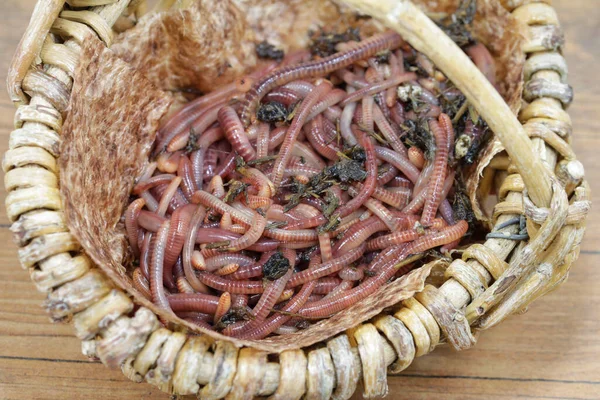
<box><xmin>343</xmin><ymin>0</ymin><xmax>552</xmax><ymax>207</ymax></box>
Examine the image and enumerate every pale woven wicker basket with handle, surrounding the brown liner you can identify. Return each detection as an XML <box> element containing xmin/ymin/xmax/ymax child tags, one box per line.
<box><xmin>3</xmin><ymin>0</ymin><xmax>590</xmax><ymax>399</ymax></box>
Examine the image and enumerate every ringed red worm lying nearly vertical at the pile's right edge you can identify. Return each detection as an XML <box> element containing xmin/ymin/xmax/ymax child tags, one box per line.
<box><xmin>421</xmin><ymin>114</ymin><xmax>448</xmax><ymax>226</ymax></box>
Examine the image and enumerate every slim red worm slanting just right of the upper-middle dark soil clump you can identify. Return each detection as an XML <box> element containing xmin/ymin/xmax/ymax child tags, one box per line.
<box><xmin>272</xmin><ymin>82</ymin><xmax>331</xmax><ymax>188</ymax></box>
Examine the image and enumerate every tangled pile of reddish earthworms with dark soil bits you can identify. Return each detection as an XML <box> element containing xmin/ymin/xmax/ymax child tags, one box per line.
<box><xmin>125</xmin><ymin>32</ymin><xmax>491</xmax><ymax>339</ymax></box>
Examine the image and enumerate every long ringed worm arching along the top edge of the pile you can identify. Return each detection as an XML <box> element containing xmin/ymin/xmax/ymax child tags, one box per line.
<box><xmin>240</xmin><ymin>31</ymin><xmax>402</xmax><ymax>126</ymax></box>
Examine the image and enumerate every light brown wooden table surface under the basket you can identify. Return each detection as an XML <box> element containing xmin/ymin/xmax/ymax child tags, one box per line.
<box><xmin>0</xmin><ymin>0</ymin><xmax>600</xmax><ymax>400</ymax></box>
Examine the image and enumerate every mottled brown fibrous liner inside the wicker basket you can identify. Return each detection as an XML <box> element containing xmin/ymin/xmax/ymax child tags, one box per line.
<box><xmin>61</xmin><ymin>0</ymin><xmax>524</xmax><ymax>352</ymax></box>
